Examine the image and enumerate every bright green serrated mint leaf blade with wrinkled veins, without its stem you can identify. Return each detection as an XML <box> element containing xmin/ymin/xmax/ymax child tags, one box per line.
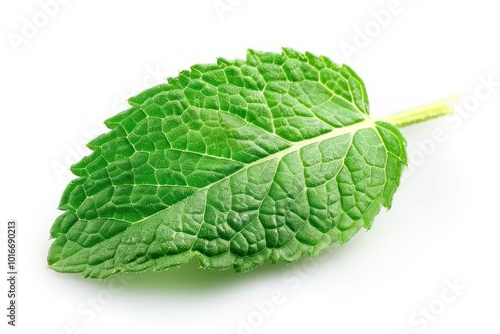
<box><xmin>48</xmin><ymin>49</ymin><xmax>406</xmax><ymax>278</ymax></box>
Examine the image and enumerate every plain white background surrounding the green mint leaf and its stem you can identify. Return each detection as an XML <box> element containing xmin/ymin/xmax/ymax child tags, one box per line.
<box><xmin>0</xmin><ymin>0</ymin><xmax>500</xmax><ymax>334</ymax></box>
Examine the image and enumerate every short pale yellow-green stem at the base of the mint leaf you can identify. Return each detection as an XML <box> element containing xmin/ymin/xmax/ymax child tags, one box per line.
<box><xmin>382</xmin><ymin>95</ymin><xmax>459</xmax><ymax>127</ymax></box>
